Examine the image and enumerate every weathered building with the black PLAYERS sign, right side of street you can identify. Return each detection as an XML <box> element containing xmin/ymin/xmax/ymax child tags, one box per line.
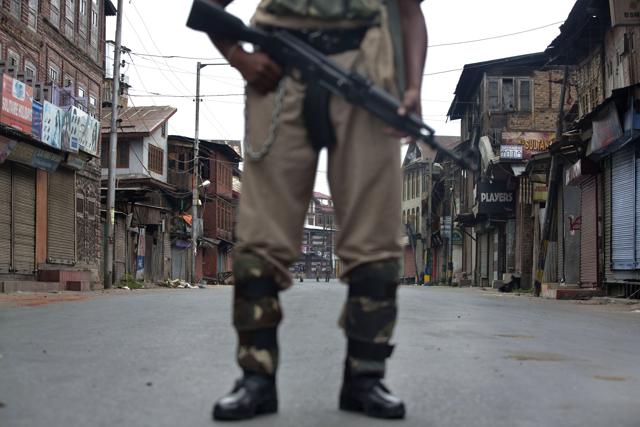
<box><xmin>449</xmin><ymin>53</ymin><xmax>576</xmax><ymax>286</ymax></box>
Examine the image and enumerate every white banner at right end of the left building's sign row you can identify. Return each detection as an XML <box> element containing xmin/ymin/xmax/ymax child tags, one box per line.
<box><xmin>62</xmin><ymin>107</ymin><xmax>100</xmax><ymax>156</ymax></box>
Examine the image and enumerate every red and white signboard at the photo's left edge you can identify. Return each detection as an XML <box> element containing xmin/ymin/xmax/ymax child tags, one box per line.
<box><xmin>0</xmin><ymin>74</ymin><xmax>33</xmax><ymax>135</ymax></box>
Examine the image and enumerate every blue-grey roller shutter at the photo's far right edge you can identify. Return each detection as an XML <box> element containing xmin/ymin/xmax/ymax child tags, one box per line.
<box><xmin>611</xmin><ymin>147</ymin><xmax>636</xmax><ymax>270</ymax></box>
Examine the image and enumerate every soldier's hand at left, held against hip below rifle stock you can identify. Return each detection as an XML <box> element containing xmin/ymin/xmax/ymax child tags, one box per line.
<box><xmin>230</xmin><ymin>50</ymin><xmax>282</xmax><ymax>94</ymax></box>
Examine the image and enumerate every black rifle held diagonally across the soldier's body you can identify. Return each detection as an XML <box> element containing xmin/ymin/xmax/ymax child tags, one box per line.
<box><xmin>187</xmin><ymin>0</ymin><xmax>477</xmax><ymax>171</ymax></box>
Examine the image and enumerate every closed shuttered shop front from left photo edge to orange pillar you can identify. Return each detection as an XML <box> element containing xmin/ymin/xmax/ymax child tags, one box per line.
<box><xmin>0</xmin><ymin>162</ymin><xmax>36</xmax><ymax>274</ymax></box>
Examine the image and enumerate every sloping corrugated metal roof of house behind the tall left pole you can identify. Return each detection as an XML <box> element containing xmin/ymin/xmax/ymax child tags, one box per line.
<box><xmin>101</xmin><ymin>106</ymin><xmax>178</xmax><ymax>136</ymax></box>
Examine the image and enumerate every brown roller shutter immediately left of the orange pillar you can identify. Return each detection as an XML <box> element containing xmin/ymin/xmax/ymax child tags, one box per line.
<box><xmin>13</xmin><ymin>165</ymin><xmax>36</xmax><ymax>274</ymax></box>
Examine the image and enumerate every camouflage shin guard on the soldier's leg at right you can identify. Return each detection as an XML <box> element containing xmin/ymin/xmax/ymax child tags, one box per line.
<box><xmin>340</xmin><ymin>260</ymin><xmax>399</xmax><ymax>375</ymax></box>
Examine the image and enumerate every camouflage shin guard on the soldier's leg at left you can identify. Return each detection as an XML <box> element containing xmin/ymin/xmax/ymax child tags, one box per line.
<box><xmin>233</xmin><ymin>253</ymin><xmax>282</xmax><ymax>376</ymax></box>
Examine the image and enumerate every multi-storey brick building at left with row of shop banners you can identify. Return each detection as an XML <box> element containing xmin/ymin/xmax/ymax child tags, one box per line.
<box><xmin>0</xmin><ymin>0</ymin><xmax>116</xmax><ymax>291</ymax></box>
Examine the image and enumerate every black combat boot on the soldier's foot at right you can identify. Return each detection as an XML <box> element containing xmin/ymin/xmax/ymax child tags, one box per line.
<box><xmin>339</xmin><ymin>363</ymin><xmax>405</xmax><ymax>419</ymax></box>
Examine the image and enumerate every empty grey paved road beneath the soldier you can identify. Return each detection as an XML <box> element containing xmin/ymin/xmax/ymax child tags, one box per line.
<box><xmin>0</xmin><ymin>282</ymin><xmax>640</xmax><ymax>427</ymax></box>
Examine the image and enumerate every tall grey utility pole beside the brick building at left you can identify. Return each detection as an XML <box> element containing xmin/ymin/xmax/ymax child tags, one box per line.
<box><xmin>104</xmin><ymin>0</ymin><xmax>123</xmax><ymax>289</ymax></box>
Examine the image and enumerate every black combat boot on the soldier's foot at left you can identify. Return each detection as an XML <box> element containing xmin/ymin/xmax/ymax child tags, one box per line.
<box><xmin>213</xmin><ymin>373</ymin><xmax>278</xmax><ymax>420</ymax></box>
